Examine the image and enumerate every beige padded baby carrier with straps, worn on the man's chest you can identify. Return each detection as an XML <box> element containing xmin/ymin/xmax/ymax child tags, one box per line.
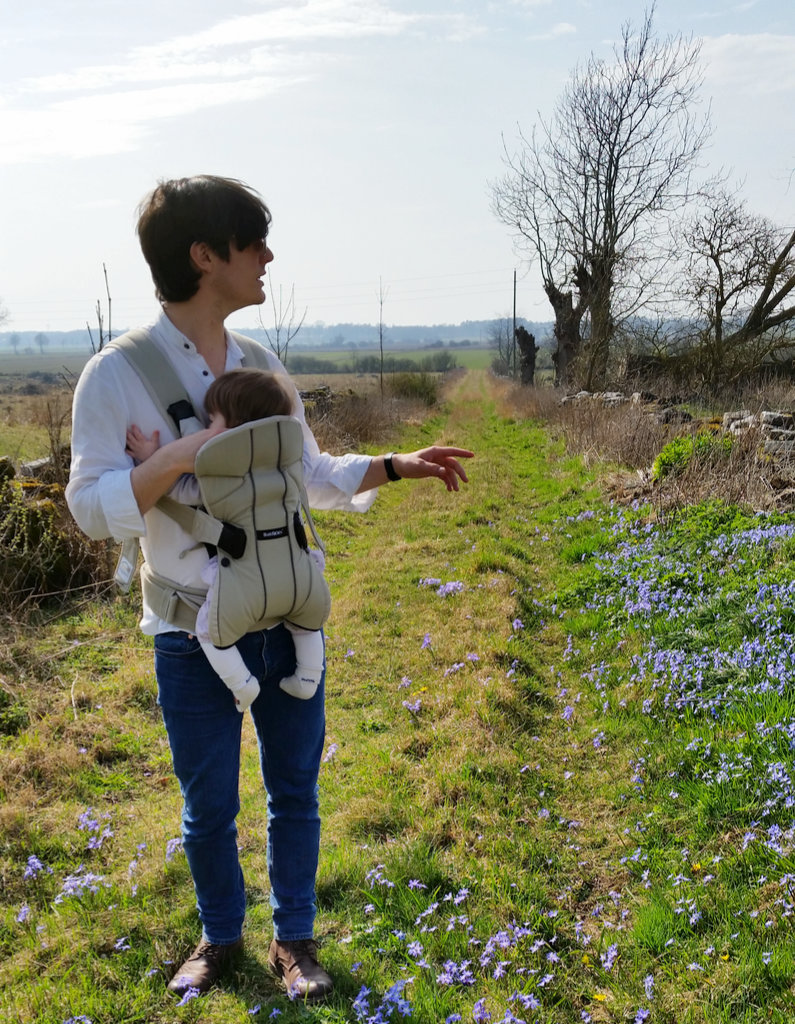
<box><xmin>106</xmin><ymin>331</ymin><xmax>331</xmax><ymax>647</ymax></box>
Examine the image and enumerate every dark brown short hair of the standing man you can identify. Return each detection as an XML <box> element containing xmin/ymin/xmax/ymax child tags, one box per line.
<box><xmin>137</xmin><ymin>174</ymin><xmax>270</xmax><ymax>302</ymax></box>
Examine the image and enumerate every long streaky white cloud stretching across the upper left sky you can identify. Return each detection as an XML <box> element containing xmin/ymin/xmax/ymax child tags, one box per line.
<box><xmin>0</xmin><ymin>0</ymin><xmax>479</xmax><ymax>164</ymax></box>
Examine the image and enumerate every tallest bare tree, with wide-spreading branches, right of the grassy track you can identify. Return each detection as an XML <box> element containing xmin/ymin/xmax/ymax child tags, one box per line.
<box><xmin>492</xmin><ymin>5</ymin><xmax>711</xmax><ymax>387</ymax></box>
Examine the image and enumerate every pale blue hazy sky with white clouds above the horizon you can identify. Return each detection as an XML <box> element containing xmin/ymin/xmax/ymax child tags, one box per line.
<box><xmin>0</xmin><ymin>0</ymin><xmax>795</xmax><ymax>332</ymax></box>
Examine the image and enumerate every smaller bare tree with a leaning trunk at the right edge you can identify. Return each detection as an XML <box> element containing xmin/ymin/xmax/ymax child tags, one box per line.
<box><xmin>683</xmin><ymin>189</ymin><xmax>795</xmax><ymax>388</ymax></box>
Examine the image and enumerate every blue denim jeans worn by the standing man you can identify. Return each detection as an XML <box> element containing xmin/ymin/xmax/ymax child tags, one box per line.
<box><xmin>155</xmin><ymin>626</ymin><xmax>326</xmax><ymax>943</ymax></box>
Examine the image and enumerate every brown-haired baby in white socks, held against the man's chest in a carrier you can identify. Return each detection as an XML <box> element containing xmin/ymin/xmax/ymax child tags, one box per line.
<box><xmin>126</xmin><ymin>368</ymin><xmax>324</xmax><ymax>712</ymax></box>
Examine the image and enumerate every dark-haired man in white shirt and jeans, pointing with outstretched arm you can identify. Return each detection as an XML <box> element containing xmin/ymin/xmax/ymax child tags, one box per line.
<box><xmin>67</xmin><ymin>175</ymin><xmax>472</xmax><ymax>999</ymax></box>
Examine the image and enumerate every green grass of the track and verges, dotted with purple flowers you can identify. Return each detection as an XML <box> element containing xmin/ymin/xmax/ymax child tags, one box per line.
<box><xmin>0</xmin><ymin>374</ymin><xmax>795</xmax><ymax>1024</ymax></box>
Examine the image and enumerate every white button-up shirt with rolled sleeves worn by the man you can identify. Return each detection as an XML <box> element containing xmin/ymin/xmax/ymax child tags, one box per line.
<box><xmin>67</xmin><ymin>312</ymin><xmax>377</xmax><ymax>636</ymax></box>
